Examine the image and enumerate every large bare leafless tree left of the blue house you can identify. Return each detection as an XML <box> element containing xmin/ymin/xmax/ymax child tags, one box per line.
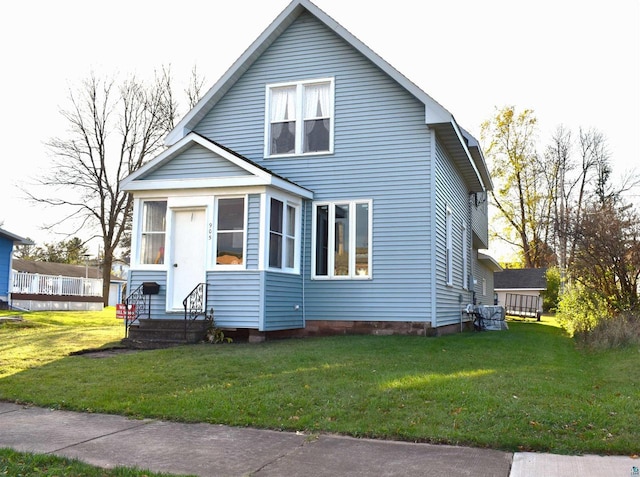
<box><xmin>26</xmin><ymin>68</ymin><xmax>177</xmax><ymax>304</ymax></box>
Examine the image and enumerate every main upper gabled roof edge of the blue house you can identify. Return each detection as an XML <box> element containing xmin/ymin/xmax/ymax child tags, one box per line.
<box><xmin>165</xmin><ymin>0</ymin><xmax>493</xmax><ymax>192</ymax></box>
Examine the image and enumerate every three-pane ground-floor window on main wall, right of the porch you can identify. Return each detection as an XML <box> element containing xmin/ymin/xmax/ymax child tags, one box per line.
<box><xmin>313</xmin><ymin>201</ymin><xmax>372</xmax><ymax>279</ymax></box>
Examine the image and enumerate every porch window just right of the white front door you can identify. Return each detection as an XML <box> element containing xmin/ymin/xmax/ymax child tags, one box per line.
<box><xmin>216</xmin><ymin>197</ymin><xmax>245</xmax><ymax>265</ymax></box>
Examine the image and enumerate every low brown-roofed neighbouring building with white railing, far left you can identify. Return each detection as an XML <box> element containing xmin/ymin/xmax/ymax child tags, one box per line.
<box><xmin>12</xmin><ymin>259</ymin><xmax>126</xmax><ymax>310</ymax></box>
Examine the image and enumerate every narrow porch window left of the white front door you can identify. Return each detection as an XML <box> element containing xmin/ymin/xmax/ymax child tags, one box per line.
<box><xmin>140</xmin><ymin>200</ymin><xmax>167</xmax><ymax>264</ymax></box>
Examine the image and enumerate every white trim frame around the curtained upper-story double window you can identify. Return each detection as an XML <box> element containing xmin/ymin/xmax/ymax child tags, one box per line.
<box><xmin>264</xmin><ymin>77</ymin><xmax>335</xmax><ymax>158</ymax></box>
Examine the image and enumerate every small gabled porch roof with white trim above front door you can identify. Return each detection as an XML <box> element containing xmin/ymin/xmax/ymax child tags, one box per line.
<box><xmin>120</xmin><ymin>132</ymin><xmax>313</xmax><ymax>199</ymax></box>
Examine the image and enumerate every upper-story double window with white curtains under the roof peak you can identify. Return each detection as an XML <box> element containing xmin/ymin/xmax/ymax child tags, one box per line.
<box><xmin>265</xmin><ymin>79</ymin><xmax>334</xmax><ymax>157</ymax></box>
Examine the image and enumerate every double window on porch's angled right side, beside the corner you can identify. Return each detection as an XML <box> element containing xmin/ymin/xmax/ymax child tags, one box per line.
<box><xmin>269</xmin><ymin>198</ymin><xmax>299</xmax><ymax>270</ymax></box>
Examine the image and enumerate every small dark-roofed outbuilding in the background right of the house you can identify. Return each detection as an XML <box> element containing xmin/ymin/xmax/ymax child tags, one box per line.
<box><xmin>494</xmin><ymin>268</ymin><xmax>547</xmax><ymax>314</ymax></box>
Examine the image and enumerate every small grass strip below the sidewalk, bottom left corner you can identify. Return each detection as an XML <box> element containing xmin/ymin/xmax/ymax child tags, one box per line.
<box><xmin>0</xmin><ymin>449</ymin><xmax>195</xmax><ymax>477</ymax></box>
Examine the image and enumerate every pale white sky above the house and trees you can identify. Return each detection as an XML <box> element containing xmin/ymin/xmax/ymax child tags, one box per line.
<box><xmin>0</xmin><ymin>0</ymin><xmax>640</xmax><ymax>254</ymax></box>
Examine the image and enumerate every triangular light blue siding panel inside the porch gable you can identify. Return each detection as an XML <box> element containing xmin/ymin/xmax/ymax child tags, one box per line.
<box><xmin>144</xmin><ymin>144</ymin><xmax>249</xmax><ymax>180</ymax></box>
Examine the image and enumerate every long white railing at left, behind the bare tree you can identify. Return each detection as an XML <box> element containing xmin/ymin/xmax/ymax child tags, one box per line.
<box><xmin>11</xmin><ymin>271</ymin><xmax>102</xmax><ymax>296</ymax></box>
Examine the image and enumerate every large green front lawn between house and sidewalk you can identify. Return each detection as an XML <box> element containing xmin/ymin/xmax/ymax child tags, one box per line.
<box><xmin>0</xmin><ymin>310</ymin><xmax>640</xmax><ymax>455</ymax></box>
